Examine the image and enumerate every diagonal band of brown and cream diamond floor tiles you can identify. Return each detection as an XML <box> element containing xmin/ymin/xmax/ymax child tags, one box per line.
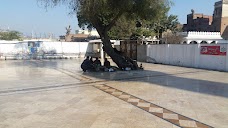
<box><xmin>95</xmin><ymin>85</ymin><xmax>212</xmax><ymax>128</ymax></box>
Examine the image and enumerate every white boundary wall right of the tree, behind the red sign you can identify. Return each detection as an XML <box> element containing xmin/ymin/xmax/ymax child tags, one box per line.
<box><xmin>147</xmin><ymin>44</ymin><xmax>228</xmax><ymax>71</ymax></box>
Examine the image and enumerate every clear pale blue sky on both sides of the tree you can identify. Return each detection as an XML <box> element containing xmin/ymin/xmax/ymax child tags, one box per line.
<box><xmin>0</xmin><ymin>0</ymin><xmax>218</xmax><ymax>37</ymax></box>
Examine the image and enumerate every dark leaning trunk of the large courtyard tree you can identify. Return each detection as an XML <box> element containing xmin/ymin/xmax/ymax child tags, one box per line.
<box><xmin>97</xmin><ymin>29</ymin><xmax>139</xmax><ymax>70</ymax></box>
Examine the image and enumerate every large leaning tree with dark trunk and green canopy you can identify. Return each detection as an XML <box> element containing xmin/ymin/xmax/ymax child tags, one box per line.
<box><xmin>39</xmin><ymin>0</ymin><xmax>169</xmax><ymax>69</ymax></box>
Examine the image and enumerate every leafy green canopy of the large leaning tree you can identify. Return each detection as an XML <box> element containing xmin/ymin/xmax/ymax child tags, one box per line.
<box><xmin>38</xmin><ymin>0</ymin><xmax>179</xmax><ymax>39</ymax></box>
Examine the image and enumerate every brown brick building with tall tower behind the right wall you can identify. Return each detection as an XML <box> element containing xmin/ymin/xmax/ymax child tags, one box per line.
<box><xmin>183</xmin><ymin>0</ymin><xmax>228</xmax><ymax>40</ymax></box>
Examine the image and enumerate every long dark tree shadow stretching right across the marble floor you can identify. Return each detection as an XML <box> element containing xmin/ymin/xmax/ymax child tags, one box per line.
<box><xmin>83</xmin><ymin>70</ymin><xmax>228</xmax><ymax>98</ymax></box>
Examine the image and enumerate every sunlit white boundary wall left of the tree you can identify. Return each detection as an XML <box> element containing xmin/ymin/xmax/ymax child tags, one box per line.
<box><xmin>0</xmin><ymin>41</ymin><xmax>91</xmax><ymax>59</ymax></box>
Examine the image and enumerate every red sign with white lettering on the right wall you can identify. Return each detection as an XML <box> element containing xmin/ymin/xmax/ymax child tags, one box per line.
<box><xmin>200</xmin><ymin>46</ymin><xmax>227</xmax><ymax>56</ymax></box>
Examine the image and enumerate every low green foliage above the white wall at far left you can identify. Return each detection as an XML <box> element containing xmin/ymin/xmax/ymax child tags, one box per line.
<box><xmin>0</xmin><ymin>31</ymin><xmax>21</xmax><ymax>40</ymax></box>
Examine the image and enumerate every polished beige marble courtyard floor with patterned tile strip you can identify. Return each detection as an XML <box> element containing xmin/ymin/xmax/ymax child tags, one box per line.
<box><xmin>0</xmin><ymin>59</ymin><xmax>228</xmax><ymax>128</ymax></box>
